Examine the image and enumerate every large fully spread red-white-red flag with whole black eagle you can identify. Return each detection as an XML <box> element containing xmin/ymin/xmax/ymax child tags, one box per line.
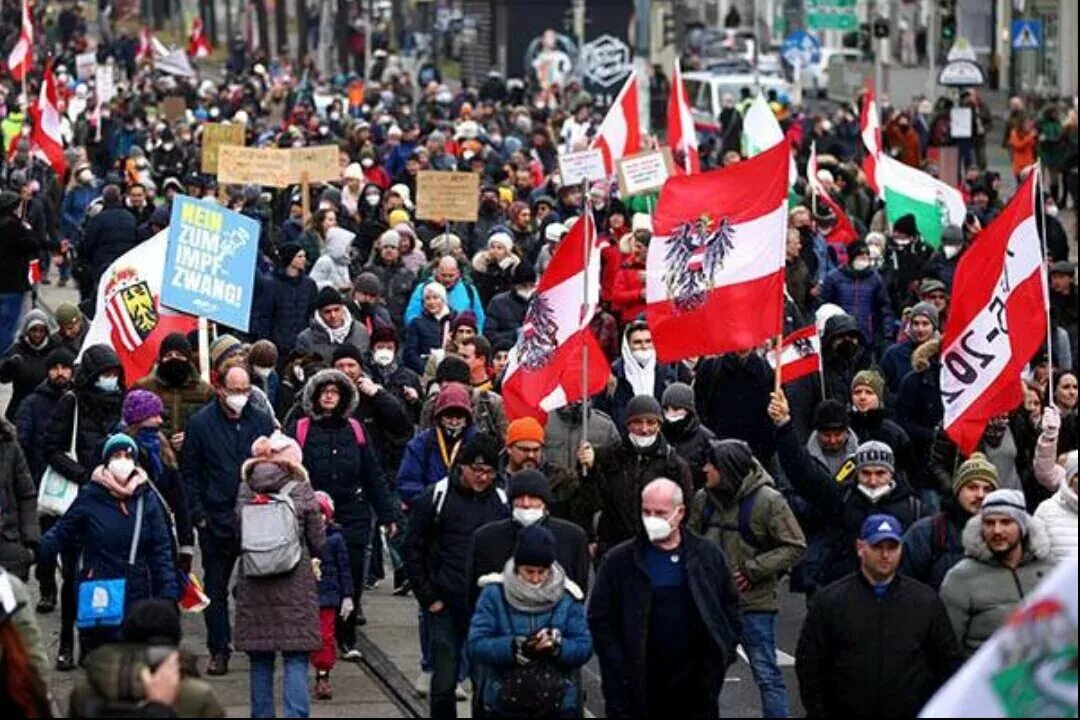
<box><xmin>646</xmin><ymin>142</ymin><xmax>792</xmax><ymax>363</ymax></box>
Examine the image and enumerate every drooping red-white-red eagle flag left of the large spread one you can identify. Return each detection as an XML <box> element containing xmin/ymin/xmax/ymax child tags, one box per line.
<box><xmin>502</xmin><ymin>212</ymin><xmax>611</xmax><ymax>422</ymax></box>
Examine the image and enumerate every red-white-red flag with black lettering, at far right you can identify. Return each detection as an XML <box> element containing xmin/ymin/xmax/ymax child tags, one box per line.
<box><xmin>941</xmin><ymin>173</ymin><xmax>1049</xmax><ymax>456</ymax></box>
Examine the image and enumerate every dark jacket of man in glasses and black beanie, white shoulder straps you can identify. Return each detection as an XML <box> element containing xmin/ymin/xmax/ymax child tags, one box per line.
<box><xmin>404</xmin><ymin>468</ymin><xmax>510</xmax><ymax>609</ymax></box>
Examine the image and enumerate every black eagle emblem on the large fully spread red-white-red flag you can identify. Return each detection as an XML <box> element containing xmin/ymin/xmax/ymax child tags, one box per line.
<box><xmin>663</xmin><ymin>215</ymin><xmax>735</xmax><ymax>313</ymax></box>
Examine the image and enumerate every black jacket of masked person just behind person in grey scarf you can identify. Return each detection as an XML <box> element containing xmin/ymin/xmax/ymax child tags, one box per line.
<box><xmin>467</xmin><ymin>515</ymin><xmax>591</xmax><ymax>608</ymax></box>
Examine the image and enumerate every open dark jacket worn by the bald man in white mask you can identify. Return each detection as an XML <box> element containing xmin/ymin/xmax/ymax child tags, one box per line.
<box><xmin>589</xmin><ymin>530</ymin><xmax>742</xmax><ymax>718</ymax></box>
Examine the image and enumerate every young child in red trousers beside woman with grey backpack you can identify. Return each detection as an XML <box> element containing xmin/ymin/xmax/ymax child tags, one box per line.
<box><xmin>311</xmin><ymin>490</ymin><xmax>353</xmax><ymax>699</ymax></box>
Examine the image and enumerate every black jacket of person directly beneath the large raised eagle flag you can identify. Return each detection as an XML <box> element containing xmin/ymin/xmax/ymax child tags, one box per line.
<box><xmin>694</xmin><ymin>354</ymin><xmax>777</xmax><ymax>466</ymax></box>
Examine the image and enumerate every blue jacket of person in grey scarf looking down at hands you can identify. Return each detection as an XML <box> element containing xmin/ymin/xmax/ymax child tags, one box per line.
<box><xmin>469</xmin><ymin>573</ymin><xmax>593</xmax><ymax>717</ymax></box>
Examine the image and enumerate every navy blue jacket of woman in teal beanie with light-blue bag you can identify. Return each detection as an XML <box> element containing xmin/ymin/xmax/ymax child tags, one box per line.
<box><xmin>39</xmin><ymin>483</ymin><xmax>180</xmax><ymax>607</ymax></box>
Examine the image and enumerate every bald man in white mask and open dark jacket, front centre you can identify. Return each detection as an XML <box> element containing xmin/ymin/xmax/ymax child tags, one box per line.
<box><xmin>589</xmin><ymin>478</ymin><xmax>741</xmax><ymax>718</ymax></box>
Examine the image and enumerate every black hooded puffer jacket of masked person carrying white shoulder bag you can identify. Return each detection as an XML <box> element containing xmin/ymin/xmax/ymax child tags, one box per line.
<box><xmin>45</xmin><ymin>345</ymin><xmax>124</xmax><ymax>485</ymax></box>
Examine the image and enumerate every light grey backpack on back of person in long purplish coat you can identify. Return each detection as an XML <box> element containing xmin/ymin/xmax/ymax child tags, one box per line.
<box><xmin>240</xmin><ymin>480</ymin><xmax>303</xmax><ymax>578</ymax></box>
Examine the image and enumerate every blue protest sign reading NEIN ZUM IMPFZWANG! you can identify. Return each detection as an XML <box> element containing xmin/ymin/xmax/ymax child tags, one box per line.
<box><xmin>161</xmin><ymin>195</ymin><xmax>259</xmax><ymax>332</ymax></box>
